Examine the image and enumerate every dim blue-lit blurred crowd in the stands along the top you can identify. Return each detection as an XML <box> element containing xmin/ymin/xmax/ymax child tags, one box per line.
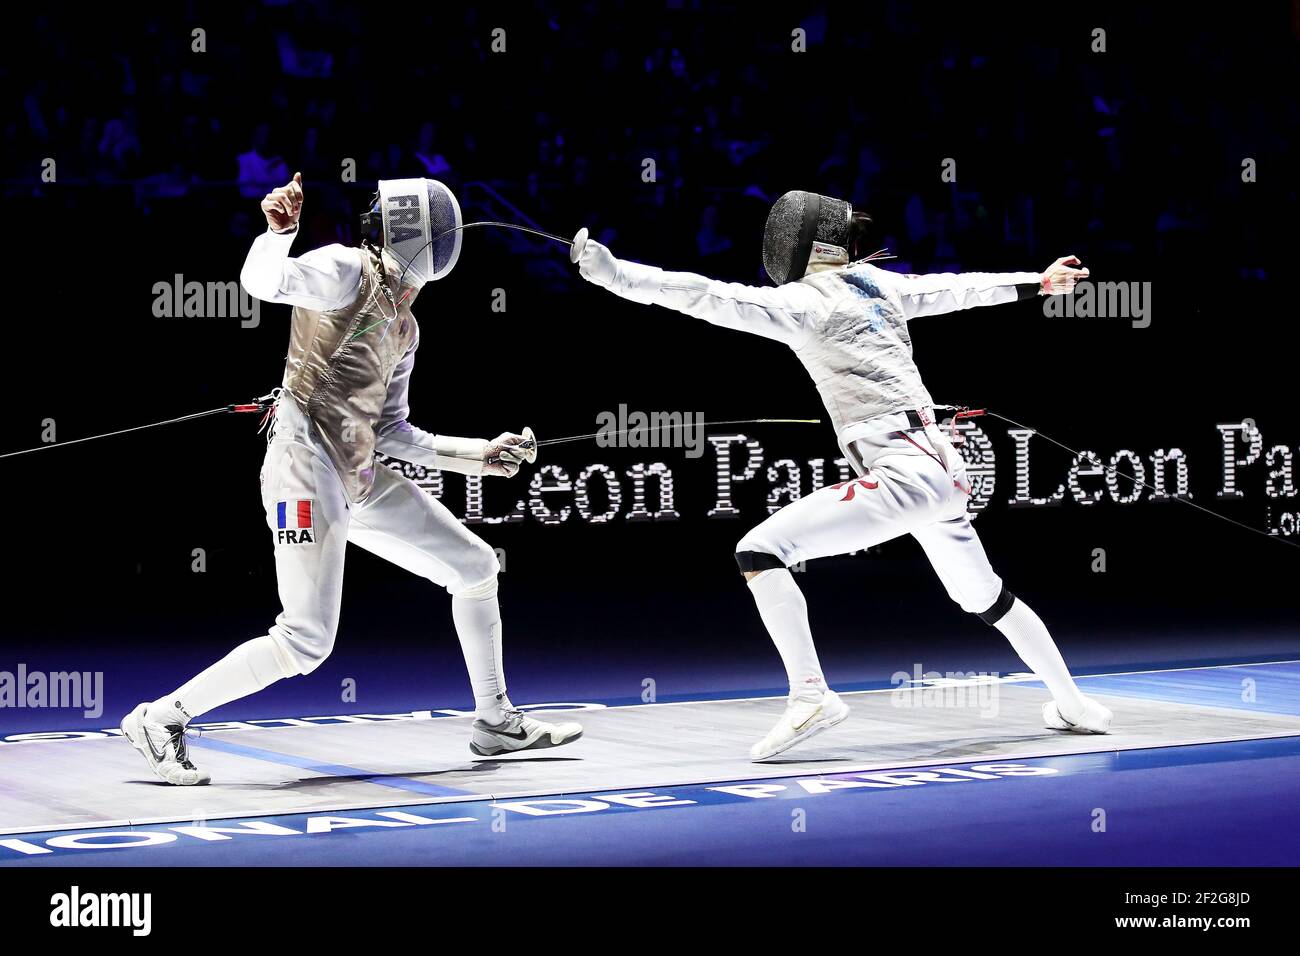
<box><xmin>0</xmin><ymin>0</ymin><xmax>1300</xmax><ymax>287</ymax></box>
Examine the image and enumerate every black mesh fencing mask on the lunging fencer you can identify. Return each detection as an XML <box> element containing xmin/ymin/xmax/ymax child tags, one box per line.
<box><xmin>763</xmin><ymin>190</ymin><xmax>871</xmax><ymax>285</ymax></box>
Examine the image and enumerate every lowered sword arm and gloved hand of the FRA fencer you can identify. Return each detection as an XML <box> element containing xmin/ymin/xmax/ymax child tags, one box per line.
<box><xmin>374</xmin><ymin>345</ymin><xmax>537</xmax><ymax>477</ymax></box>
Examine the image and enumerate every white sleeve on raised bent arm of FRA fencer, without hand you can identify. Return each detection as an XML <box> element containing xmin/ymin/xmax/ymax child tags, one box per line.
<box><xmin>239</xmin><ymin>229</ymin><xmax>361</xmax><ymax>312</ymax></box>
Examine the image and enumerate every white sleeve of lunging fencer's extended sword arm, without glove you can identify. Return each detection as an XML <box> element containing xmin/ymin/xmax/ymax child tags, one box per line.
<box><xmin>595</xmin><ymin>259</ymin><xmax>826</xmax><ymax>349</ymax></box>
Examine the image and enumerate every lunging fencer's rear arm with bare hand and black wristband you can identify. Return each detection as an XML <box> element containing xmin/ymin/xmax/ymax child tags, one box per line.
<box><xmin>880</xmin><ymin>256</ymin><xmax>1088</xmax><ymax>319</ymax></box>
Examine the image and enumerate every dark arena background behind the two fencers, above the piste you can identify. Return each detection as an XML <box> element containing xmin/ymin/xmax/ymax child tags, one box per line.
<box><xmin>0</xmin><ymin>3</ymin><xmax>1300</xmax><ymax>723</ymax></box>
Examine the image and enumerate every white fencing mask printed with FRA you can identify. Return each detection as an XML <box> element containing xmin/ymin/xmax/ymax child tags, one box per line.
<box><xmin>361</xmin><ymin>179</ymin><xmax>463</xmax><ymax>287</ymax></box>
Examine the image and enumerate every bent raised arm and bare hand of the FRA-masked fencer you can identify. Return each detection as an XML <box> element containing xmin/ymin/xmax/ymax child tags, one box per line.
<box><xmin>239</xmin><ymin>167</ymin><xmax>361</xmax><ymax>312</ymax></box>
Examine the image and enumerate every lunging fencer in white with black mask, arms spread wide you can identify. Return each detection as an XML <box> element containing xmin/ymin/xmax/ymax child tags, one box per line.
<box><xmin>573</xmin><ymin>191</ymin><xmax>1112</xmax><ymax>760</ymax></box>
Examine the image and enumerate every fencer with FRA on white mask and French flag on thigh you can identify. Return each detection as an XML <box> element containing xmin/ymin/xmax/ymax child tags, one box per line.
<box><xmin>122</xmin><ymin>174</ymin><xmax>582</xmax><ymax>786</ymax></box>
